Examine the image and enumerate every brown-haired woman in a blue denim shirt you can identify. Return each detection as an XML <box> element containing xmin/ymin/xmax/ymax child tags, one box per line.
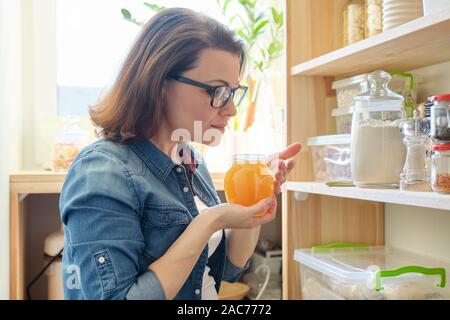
<box><xmin>60</xmin><ymin>8</ymin><xmax>300</xmax><ymax>299</ymax></box>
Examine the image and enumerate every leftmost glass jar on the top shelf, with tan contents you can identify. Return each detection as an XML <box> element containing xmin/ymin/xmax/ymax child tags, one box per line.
<box><xmin>343</xmin><ymin>0</ymin><xmax>366</xmax><ymax>46</ymax></box>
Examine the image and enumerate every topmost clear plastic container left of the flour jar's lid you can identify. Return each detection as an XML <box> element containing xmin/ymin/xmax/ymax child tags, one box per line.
<box><xmin>331</xmin><ymin>74</ymin><xmax>369</xmax><ymax>108</ymax></box>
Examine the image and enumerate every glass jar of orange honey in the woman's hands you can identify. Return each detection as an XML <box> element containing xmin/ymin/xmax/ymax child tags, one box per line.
<box><xmin>224</xmin><ymin>154</ymin><xmax>274</xmax><ymax>216</ymax></box>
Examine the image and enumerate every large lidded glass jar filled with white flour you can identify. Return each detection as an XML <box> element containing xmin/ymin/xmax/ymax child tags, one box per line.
<box><xmin>351</xmin><ymin>70</ymin><xmax>406</xmax><ymax>188</ymax></box>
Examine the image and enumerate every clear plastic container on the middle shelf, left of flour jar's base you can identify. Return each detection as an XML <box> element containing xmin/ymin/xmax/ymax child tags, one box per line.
<box><xmin>308</xmin><ymin>134</ymin><xmax>352</xmax><ymax>182</ymax></box>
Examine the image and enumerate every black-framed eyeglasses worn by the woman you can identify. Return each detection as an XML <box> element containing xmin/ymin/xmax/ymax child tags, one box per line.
<box><xmin>169</xmin><ymin>74</ymin><xmax>248</xmax><ymax>108</ymax></box>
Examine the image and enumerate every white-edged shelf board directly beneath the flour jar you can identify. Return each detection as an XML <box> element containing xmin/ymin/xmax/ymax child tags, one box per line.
<box><xmin>286</xmin><ymin>182</ymin><xmax>450</xmax><ymax>210</ymax></box>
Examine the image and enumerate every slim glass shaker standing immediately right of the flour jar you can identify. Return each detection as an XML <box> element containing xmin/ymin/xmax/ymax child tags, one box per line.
<box><xmin>400</xmin><ymin>110</ymin><xmax>432</xmax><ymax>191</ymax></box>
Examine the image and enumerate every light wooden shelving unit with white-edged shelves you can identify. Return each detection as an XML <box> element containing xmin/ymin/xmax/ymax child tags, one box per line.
<box><xmin>282</xmin><ymin>0</ymin><xmax>450</xmax><ymax>299</ymax></box>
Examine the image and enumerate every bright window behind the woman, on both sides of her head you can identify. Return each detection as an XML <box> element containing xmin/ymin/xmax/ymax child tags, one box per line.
<box><xmin>53</xmin><ymin>0</ymin><xmax>284</xmax><ymax>172</ymax></box>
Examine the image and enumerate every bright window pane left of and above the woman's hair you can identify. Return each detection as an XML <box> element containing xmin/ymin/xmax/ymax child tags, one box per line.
<box><xmin>56</xmin><ymin>0</ymin><xmax>225</xmax><ymax>116</ymax></box>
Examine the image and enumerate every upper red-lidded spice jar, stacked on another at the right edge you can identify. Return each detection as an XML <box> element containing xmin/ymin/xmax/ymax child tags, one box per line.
<box><xmin>430</xmin><ymin>94</ymin><xmax>450</xmax><ymax>144</ymax></box>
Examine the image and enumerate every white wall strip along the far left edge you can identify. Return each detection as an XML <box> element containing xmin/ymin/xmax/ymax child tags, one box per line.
<box><xmin>0</xmin><ymin>0</ymin><xmax>22</xmax><ymax>299</ymax></box>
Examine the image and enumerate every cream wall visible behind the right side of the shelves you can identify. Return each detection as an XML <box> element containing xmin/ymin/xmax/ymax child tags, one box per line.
<box><xmin>385</xmin><ymin>61</ymin><xmax>450</xmax><ymax>261</ymax></box>
